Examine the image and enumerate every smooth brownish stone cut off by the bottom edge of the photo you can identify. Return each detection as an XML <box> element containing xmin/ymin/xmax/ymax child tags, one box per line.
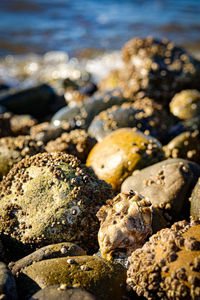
<box><xmin>29</xmin><ymin>284</ymin><xmax>97</xmax><ymax>300</ymax></box>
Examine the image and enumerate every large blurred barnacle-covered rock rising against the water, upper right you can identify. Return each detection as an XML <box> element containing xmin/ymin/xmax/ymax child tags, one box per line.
<box><xmin>119</xmin><ymin>37</ymin><xmax>200</xmax><ymax>106</ymax></box>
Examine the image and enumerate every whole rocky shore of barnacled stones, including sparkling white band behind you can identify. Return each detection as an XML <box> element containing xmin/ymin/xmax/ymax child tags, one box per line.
<box><xmin>0</xmin><ymin>37</ymin><xmax>200</xmax><ymax>300</ymax></box>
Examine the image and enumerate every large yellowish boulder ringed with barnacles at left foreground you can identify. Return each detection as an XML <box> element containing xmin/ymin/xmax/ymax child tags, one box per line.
<box><xmin>0</xmin><ymin>152</ymin><xmax>113</xmax><ymax>259</ymax></box>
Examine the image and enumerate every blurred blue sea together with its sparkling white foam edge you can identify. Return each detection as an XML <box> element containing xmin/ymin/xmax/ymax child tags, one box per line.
<box><xmin>0</xmin><ymin>0</ymin><xmax>200</xmax><ymax>84</ymax></box>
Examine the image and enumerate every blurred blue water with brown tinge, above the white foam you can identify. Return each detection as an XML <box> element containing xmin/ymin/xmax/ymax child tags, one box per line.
<box><xmin>0</xmin><ymin>0</ymin><xmax>200</xmax><ymax>56</ymax></box>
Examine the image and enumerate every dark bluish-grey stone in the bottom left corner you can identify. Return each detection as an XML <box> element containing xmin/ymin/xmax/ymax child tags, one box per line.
<box><xmin>0</xmin><ymin>262</ymin><xmax>18</xmax><ymax>300</ymax></box>
